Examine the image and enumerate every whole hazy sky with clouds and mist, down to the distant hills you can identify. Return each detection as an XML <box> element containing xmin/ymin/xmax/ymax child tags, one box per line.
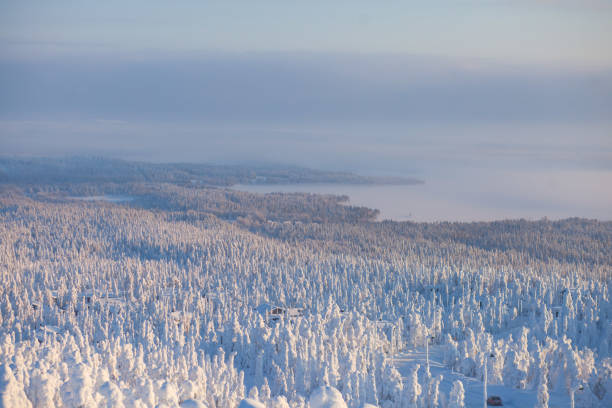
<box><xmin>0</xmin><ymin>0</ymin><xmax>612</xmax><ymax>219</ymax></box>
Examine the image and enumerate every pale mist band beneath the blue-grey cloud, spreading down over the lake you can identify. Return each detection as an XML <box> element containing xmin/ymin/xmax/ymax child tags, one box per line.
<box><xmin>5</xmin><ymin>121</ymin><xmax>612</xmax><ymax>221</ymax></box>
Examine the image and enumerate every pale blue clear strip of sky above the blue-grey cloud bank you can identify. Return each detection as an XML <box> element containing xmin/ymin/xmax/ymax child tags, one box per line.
<box><xmin>0</xmin><ymin>0</ymin><xmax>612</xmax><ymax>68</ymax></box>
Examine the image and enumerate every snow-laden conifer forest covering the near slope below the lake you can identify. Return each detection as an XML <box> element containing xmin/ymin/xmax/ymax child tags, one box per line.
<box><xmin>0</xmin><ymin>176</ymin><xmax>612</xmax><ymax>408</ymax></box>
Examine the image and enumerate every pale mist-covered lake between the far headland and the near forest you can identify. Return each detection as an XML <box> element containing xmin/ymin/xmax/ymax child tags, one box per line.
<box><xmin>233</xmin><ymin>167</ymin><xmax>612</xmax><ymax>221</ymax></box>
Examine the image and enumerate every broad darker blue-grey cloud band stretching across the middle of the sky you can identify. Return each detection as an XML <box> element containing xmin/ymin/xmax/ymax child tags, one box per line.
<box><xmin>0</xmin><ymin>53</ymin><xmax>612</xmax><ymax>122</ymax></box>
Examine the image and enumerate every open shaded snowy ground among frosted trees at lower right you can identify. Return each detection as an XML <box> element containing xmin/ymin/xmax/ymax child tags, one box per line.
<box><xmin>391</xmin><ymin>345</ymin><xmax>570</xmax><ymax>408</ymax></box>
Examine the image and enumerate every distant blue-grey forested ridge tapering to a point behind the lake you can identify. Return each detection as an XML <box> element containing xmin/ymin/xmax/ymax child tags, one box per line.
<box><xmin>0</xmin><ymin>157</ymin><xmax>422</xmax><ymax>186</ymax></box>
